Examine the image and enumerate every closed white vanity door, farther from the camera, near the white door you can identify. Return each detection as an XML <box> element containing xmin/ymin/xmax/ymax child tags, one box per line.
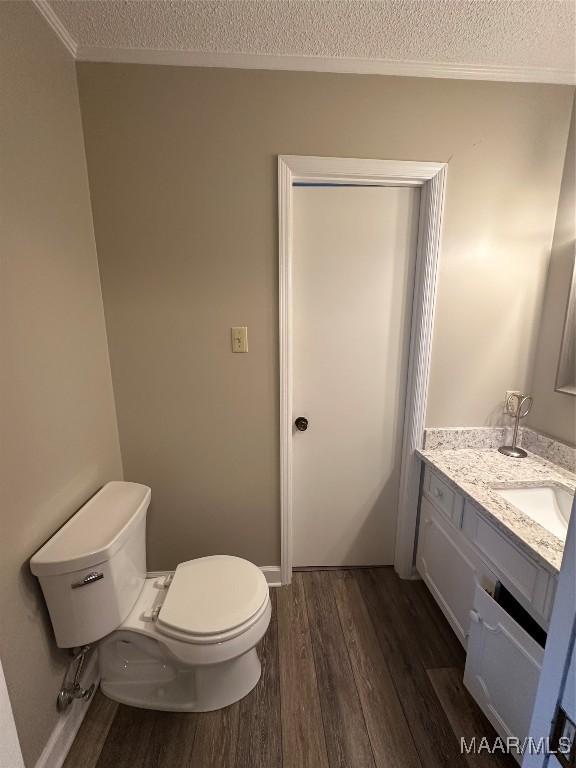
<box><xmin>416</xmin><ymin>498</ymin><xmax>496</xmax><ymax>647</ymax></box>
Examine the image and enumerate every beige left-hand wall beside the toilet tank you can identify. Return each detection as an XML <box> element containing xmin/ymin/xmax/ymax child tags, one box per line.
<box><xmin>0</xmin><ymin>2</ymin><xmax>121</xmax><ymax>768</ymax></box>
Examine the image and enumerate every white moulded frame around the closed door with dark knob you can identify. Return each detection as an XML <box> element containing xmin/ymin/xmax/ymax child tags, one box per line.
<box><xmin>278</xmin><ymin>155</ymin><xmax>448</xmax><ymax>584</ymax></box>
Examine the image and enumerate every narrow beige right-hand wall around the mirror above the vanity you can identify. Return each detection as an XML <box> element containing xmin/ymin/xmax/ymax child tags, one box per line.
<box><xmin>529</xmin><ymin>102</ymin><xmax>576</xmax><ymax>443</ymax></box>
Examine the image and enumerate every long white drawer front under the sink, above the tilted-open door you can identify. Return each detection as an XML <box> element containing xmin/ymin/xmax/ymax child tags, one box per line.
<box><xmin>462</xmin><ymin>501</ymin><xmax>555</xmax><ymax>624</ymax></box>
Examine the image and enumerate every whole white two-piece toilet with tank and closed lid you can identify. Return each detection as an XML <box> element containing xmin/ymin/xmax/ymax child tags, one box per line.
<box><xmin>30</xmin><ymin>482</ymin><xmax>271</xmax><ymax>712</ymax></box>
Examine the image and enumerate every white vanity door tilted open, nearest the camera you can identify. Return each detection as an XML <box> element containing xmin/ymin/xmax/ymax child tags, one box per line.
<box><xmin>464</xmin><ymin>587</ymin><xmax>544</xmax><ymax>756</ymax></box>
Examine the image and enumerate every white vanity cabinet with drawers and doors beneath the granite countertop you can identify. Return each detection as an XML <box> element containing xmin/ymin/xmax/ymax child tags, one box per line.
<box><xmin>416</xmin><ymin>466</ymin><xmax>556</xmax><ymax>759</ymax></box>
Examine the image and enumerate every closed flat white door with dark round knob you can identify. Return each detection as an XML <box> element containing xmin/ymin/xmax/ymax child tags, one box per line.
<box><xmin>292</xmin><ymin>186</ymin><xmax>420</xmax><ymax>566</ymax></box>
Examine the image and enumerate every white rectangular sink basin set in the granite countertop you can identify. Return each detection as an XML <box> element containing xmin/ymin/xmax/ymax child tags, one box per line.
<box><xmin>495</xmin><ymin>485</ymin><xmax>574</xmax><ymax>540</ymax></box>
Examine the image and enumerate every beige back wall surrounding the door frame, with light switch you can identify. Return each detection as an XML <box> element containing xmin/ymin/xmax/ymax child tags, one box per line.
<box><xmin>78</xmin><ymin>63</ymin><xmax>573</xmax><ymax>569</ymax></box>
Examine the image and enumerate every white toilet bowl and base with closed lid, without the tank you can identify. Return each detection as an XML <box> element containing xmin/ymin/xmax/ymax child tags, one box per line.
<box><xmin>99</xmin><ymin>556</ymin><xmax>271</xmax><ymax>712</ymax></box>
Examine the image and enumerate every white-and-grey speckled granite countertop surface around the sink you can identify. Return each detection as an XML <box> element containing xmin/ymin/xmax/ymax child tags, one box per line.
<box><xmin>416</xmin><ymin>448</ymin><xmax>576</xmax><ymax>573</ymax></box>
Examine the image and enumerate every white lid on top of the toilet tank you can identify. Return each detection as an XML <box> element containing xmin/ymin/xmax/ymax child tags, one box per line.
<box><xmin>30</xmin><ymin>481</ymin><xmax>151</xmax><ymax>576</ymax></box>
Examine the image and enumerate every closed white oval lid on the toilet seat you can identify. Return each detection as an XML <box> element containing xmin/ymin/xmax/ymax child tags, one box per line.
<box><xmin>157</xmin><ymin>555</ymin><xmax>268</xmax><ymax>635</ymax></box>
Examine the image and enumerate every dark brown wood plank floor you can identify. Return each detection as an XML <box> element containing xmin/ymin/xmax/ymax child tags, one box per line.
<box><xmin>64</xmin><ymin>568</ymin><xmax>516</xmax><ymax>768</ymax></box>
